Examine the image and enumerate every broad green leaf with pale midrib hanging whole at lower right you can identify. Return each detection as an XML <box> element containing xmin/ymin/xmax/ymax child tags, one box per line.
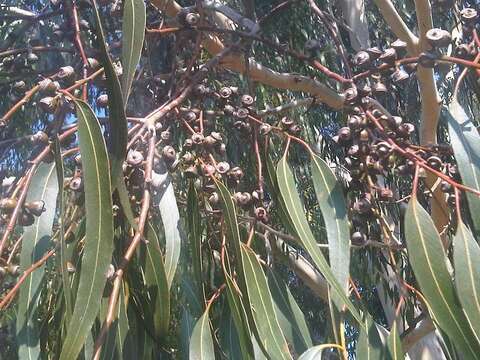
<box><xmin>405</xmin><ymin>197</ymin><xmax>480</xmax><ymax>359</ymax></box>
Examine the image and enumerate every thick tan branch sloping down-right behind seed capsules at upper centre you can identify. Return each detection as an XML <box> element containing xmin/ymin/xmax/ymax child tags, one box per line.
<box><xmin>152</xmin><ymin>0</ymin><xmax>344</xmax><ymax>109</ymax></box>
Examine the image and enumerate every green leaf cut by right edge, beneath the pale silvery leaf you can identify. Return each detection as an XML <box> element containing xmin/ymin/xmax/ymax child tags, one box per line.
<box><xmin>453</xmin><ymin>221</ymin><xmax>480</xmax><ymax>339</ymax></box>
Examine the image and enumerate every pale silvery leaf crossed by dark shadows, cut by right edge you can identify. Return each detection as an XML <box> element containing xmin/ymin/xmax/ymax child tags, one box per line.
<box><xmin>446</xmin><ymin>99</ymin><xmax>480</xmax><ymax>236</ymax></box>
